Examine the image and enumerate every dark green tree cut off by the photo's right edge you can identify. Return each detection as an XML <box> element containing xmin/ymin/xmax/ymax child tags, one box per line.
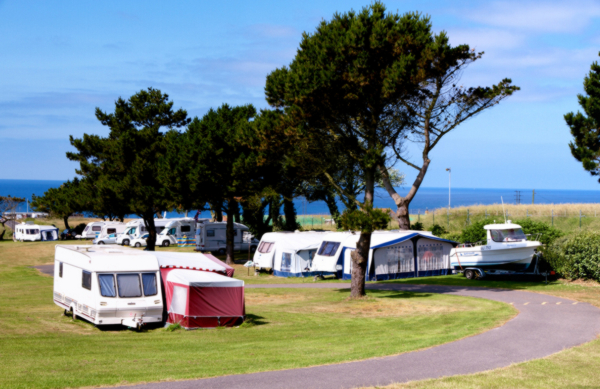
<box><xmin>565</xmin><ymin>53</ymin><xmax>600</xmax><ymax>182</ymax></box>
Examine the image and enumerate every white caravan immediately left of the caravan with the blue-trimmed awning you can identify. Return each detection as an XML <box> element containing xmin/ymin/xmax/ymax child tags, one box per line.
<box><xmin>254</xmin><ymin>231</ymin><xmax>327</xmax><ymax>277</ymax></box>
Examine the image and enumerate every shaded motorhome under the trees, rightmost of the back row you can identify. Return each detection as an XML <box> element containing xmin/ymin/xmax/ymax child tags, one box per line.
<box><xmin>196</xmin><ymin>222</ymin><xmax>259</xmax><ymax>254</ymax></box>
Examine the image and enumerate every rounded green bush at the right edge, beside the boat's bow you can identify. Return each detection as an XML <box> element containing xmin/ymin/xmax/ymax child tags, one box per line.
<box><xmin>543</xmin><ymin>231</ymin><xmax>600</xmax><ymax>281</ymax></box>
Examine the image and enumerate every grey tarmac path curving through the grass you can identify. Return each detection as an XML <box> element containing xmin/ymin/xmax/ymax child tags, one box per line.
<box><xmin>122</xmin><ymin>283</ymin><xmax>600</xmax><ymax>389</ymax></box>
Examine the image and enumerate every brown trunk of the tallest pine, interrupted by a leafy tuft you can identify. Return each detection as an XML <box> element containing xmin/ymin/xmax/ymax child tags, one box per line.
<box><xmin>350</xmin><ymin>168</ymin><xmax>375</xmax><ymax>298</ymax></box>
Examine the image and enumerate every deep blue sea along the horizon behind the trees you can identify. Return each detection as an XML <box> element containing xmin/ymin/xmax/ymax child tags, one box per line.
<box><xmin>0</xmin><ymin>179</ymin><xmax>600</xmax><ymax>217</ymax></box>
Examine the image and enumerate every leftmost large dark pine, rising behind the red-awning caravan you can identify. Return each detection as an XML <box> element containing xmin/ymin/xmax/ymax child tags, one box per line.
<box><xmin>67</xmin><ymin>88</ymin><xmax>190</xmax><ymax>250</ymax></box>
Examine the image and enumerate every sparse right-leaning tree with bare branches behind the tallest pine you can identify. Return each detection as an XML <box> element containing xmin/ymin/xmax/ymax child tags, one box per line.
<box><xmin>378</xmin><ymin>49</ymin><xmax>520</xmax><ymax>230</ymax></box>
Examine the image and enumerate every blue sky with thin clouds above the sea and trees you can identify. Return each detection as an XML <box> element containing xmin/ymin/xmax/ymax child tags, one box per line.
<box><xmin>0</xmin><ymin>0</ymin><xmax>600</xmax><ymax>189</ymax></box>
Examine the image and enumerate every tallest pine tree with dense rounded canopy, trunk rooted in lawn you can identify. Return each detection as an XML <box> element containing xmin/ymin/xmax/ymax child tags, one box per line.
<box><xmin>265</xmin><ymin>2</ymin><xmax>438</xmax><ymax>297</ymax></box>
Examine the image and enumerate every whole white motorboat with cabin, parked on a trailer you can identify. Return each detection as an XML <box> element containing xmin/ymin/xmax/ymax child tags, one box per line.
<box><xmin>450</xmin><ymin>220</ymin><xmax>542</xmax><ymax>274</ymax></box>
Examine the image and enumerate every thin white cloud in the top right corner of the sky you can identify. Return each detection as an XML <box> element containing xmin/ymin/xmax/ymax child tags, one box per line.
<box><xmin>464</xmin><ymin>0</ymin><xmax>600</xmax><ymax>33</ymax></box>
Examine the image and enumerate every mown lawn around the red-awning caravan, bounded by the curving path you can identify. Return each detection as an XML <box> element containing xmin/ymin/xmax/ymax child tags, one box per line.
<box><xmin>0</xmin><ymin>241</ymin><xmax>515</xmax><ymax>388</ymax></box>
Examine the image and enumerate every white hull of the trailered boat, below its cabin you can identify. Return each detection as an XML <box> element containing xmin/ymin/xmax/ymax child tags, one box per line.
<box><xmin>450</xmin><ymin>244</ymin><xmax>538</xmax><ymax>271</ymax></box>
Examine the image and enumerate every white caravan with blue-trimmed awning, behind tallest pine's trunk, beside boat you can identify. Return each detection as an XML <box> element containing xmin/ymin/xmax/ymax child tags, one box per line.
<box><xmin>338</xmin><ymin>231</ymin><xmax>458</xmax><ymax>281</ymax></box>
